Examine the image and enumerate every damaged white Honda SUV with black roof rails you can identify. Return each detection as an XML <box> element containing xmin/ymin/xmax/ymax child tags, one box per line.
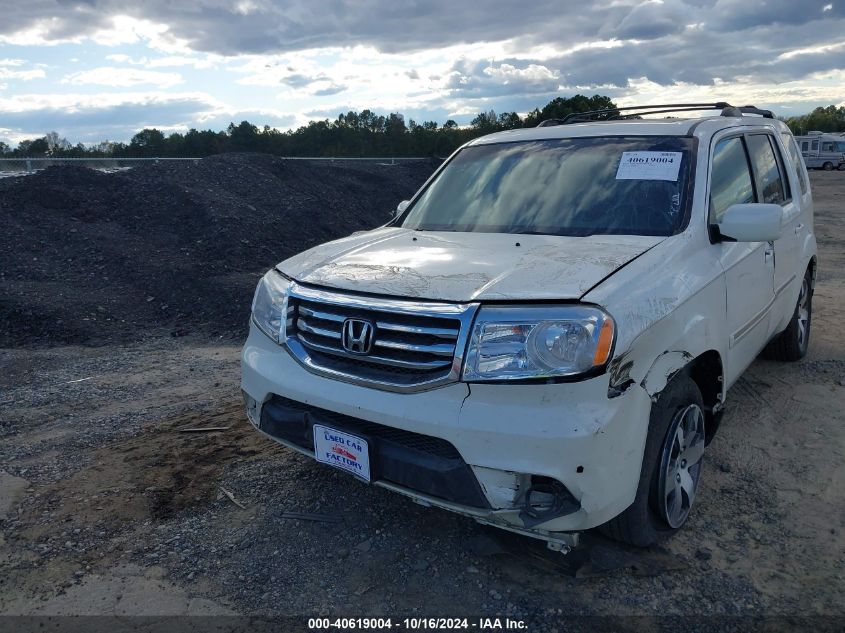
<box><xmin>242</xmin><ymin>103</ymin><xmax>816</xmax><ymax>551</ymax></box>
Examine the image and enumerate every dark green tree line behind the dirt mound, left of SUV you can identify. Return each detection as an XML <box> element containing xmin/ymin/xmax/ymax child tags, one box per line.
<box><xmin>0</xmin><ymin>95</ymin><xmax>616</xmax><ymax>158</ymax></box>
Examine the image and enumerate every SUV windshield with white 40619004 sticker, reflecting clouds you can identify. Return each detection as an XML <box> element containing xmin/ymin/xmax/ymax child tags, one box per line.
<box><xmin>401</xmin><ymin>136</ymin><xmax>692</xmax><ymax>236</ymax></box>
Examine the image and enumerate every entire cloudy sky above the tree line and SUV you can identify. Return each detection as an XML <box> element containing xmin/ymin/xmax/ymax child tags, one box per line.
<box><xmin>0</xmin><ymin>0</ymin><xmax>845</xmax><ymax>145</ymax></box>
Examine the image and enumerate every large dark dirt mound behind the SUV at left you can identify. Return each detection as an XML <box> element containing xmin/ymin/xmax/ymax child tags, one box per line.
<box><xmin>0</xmin><ymin>154</ymin><xmax>435</xmax><ymax>347</ymax></box>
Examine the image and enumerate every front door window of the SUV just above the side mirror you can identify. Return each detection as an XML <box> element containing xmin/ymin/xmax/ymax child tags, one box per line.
<box><xmin>710</xmin><ymin>137</ymin><xmax>754</xmax><ymax>224</ymax></box>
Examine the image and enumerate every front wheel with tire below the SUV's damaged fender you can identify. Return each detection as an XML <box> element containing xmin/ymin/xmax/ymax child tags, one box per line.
<box><xmin>599</xmin><ymin>373</ymin><xmax>705</xmax><ymax>547</ymax></box>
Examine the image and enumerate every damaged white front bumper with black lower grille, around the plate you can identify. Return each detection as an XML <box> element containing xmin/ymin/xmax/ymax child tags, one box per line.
<box><xmin>242</xmin><ymin>326</ymin><xmax>650</xmax><ymax>551</ymax></box>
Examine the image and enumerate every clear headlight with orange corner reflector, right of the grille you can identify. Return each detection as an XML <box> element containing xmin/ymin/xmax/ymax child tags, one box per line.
<box><xmin>463</xmin><ymin>305</ymin><xmax>614</xmax><ymax>381</ymax></box>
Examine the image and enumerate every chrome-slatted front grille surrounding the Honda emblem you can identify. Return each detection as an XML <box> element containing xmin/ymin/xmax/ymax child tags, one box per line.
<box><xmin>286</xmin><ymin>286</ymin><xmax>475</xmax><ymax>387</ymax></box>
